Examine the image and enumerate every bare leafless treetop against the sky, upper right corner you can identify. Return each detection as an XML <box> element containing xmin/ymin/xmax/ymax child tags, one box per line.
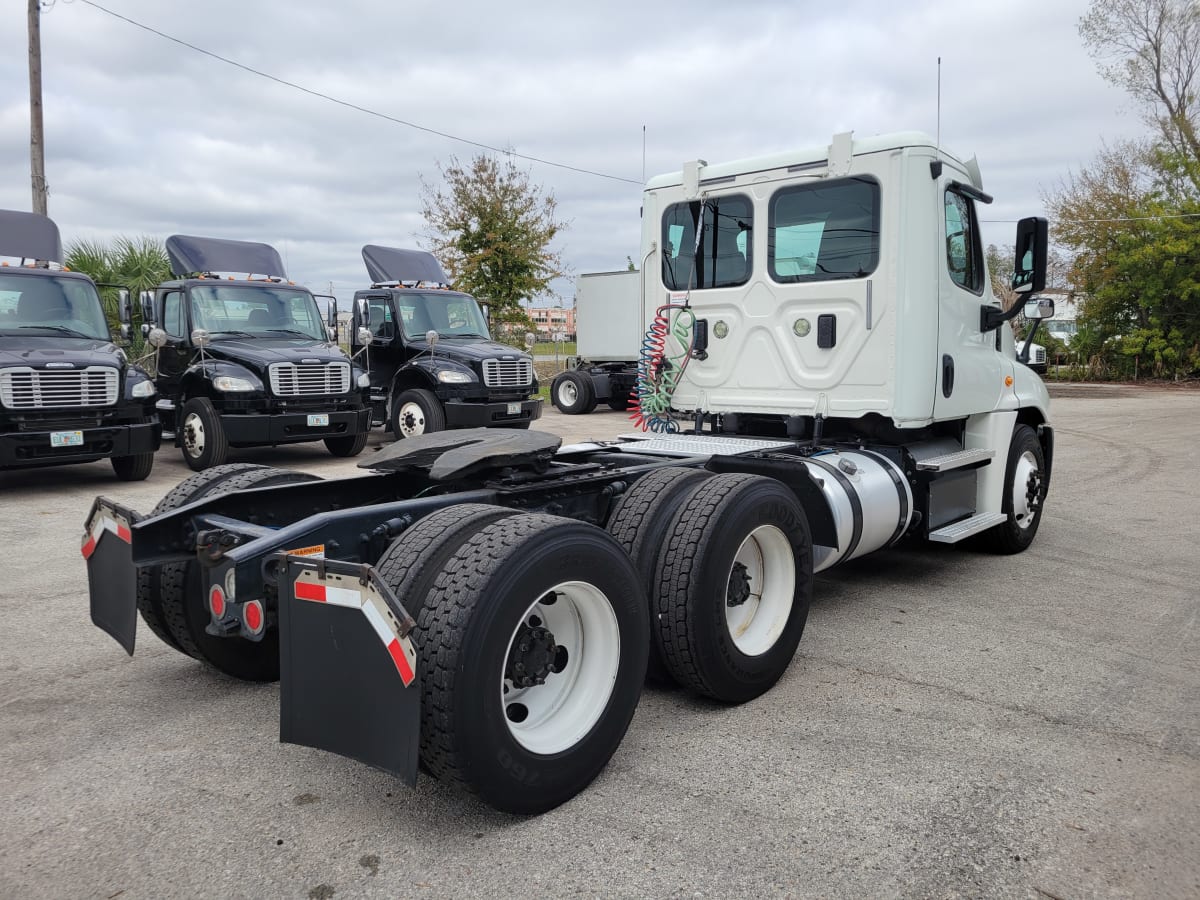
<box><xmin>1079</xmin><ymin>0</ymin><xmax>1200</xmax><ymax>177</ymax></box>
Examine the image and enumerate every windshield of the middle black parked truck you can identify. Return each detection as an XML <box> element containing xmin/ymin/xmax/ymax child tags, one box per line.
<box><xmin>188</xmin><ymin>283</ymin><xmax>329</xmax><ymax>341</ymax></box>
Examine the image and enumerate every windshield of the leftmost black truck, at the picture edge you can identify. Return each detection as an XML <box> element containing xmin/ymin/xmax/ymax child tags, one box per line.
<box><xmin>0</xmin><ymin>272</ymin><xmax>112</xmax><ymax>341</ymax></box>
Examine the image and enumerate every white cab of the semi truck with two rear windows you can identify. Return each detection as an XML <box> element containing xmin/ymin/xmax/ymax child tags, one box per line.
<box><xmin>638</xmin><ymin>132</ymin><xmax>1054</xmax><ymax>548</ymax></box>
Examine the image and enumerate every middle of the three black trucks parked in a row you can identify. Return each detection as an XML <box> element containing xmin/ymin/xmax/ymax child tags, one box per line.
<box><xmin>143</xmin><ymin>235</ymin><xmax>371</xmax><ymax>470</ymax></box>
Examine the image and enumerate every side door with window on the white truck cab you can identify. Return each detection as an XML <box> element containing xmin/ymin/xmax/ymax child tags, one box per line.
<box><xmin>934</xmin><ymin>186</ymin><xmax>1006</xmax><ymax>419</ymax></box>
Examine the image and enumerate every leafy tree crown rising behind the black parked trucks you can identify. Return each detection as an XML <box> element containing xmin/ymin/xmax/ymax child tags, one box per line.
<box><xmin>421</xmin><ymin>154</ymin><xmax>566</xmax><ymax>325</ymax></box>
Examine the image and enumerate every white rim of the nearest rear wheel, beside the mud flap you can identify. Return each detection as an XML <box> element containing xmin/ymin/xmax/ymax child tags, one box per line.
<box><xmin>500</xmin><ymin>581</ymin><xmax>620</xmax><ymax>755</ymax></box>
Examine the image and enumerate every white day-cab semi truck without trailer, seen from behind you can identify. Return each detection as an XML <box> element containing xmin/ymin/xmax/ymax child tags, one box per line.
<box><xmin>83</xmin><ymin>133</ymin><xmax>1054</xmax><ymax>814</ymax></box>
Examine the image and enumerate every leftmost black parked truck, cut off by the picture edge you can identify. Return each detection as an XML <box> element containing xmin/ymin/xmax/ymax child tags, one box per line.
<box><xmin>0</xmin><ymin>210</ymin><xmax>161</xmax><ymax>481</ymax></box>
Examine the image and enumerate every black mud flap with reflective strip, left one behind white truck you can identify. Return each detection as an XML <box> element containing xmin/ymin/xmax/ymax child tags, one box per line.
<box><xmin>82</xmin><ymin>497</ymin><xmax>142</xmax><ymax>656</ymax></box>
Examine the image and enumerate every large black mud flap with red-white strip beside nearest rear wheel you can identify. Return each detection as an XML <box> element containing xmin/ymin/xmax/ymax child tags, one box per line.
<box><xmin>280</xmin><ymin>556</ymin><xmax>421</xmax><ymax>785</ymax></box>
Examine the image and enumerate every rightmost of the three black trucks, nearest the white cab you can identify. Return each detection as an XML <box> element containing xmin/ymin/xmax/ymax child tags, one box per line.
<box><xmin>350</xmin><ymin>245</ymin><xmax>541</xmax><ymax>439</ymax></box>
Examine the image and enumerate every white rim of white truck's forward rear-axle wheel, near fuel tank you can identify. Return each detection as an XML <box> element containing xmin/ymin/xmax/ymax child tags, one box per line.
<box><xmin>725</xmin><ymin>526</ymin><xmax>796</xmax><ymax>656</ymax></box>
